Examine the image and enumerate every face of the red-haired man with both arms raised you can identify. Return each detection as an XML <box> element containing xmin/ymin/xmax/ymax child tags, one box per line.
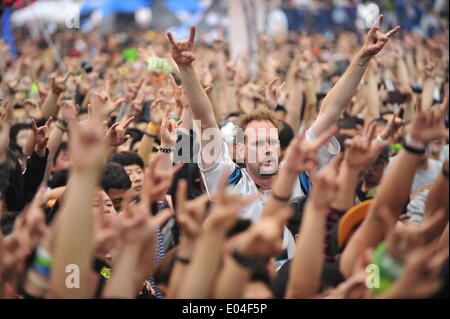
<box><xmin>244</xmin><ymin>121</ymin><xmax>280</xmax><ymax>176</ymax></box>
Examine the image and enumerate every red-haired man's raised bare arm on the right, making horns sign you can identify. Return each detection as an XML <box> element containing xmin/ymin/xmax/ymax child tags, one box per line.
<box><xmin>311</xmin><ymin>15</ymin><xmax>400</xmax><ymax>136</ymax></box>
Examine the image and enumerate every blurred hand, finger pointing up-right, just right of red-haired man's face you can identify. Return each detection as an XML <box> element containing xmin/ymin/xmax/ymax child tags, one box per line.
<box><xmin>283</xmin><ymin>126</ymin><xmax>337</xmax><ymax>174</ymax></box>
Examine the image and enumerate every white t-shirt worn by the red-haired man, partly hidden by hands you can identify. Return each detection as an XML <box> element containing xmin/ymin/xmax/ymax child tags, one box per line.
<box><xmin>198</xmin><ymin>130</ymin><xmax>340</xmax><ymax>259</ymax></box>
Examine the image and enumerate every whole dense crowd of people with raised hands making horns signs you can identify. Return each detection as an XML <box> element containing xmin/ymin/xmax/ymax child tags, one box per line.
<box><xmin>0</xmin><ymin>10</ymin><xmax>449</xmax><ymax>299</ymax></box>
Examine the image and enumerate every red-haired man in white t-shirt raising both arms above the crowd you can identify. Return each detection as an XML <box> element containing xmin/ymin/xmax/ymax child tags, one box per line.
<box><xmin>167</xmin><ymin>16</ymin><xmax>399</xmax><ymax>257</ymax></box>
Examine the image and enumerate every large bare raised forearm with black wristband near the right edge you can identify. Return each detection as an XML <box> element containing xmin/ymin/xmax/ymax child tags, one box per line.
<box><xmin>340</xmin><ymin>107</ymin><xmax>448</xmax><ymax>277</ymax></box>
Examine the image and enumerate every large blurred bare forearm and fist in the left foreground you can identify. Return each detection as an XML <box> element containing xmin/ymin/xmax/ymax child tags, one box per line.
<box><xmin>51</xmin><ymin>106</ymin><xmax>107</xmax><ymax>298</ymax></box>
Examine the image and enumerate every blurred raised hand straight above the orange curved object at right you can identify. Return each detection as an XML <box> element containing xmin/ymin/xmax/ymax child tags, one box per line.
<box><xmin>344</xmin><ymin>123</ymin><xmax>388</xmax><ymax>171</ymax></box>
